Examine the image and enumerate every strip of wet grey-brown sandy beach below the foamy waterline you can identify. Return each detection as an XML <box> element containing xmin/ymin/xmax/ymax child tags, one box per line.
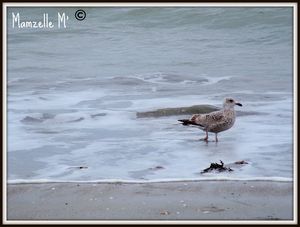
<box><xmin>7</xmin><ymin>181</ymin><xmax>293</xmax><ymax>221</ymax></box>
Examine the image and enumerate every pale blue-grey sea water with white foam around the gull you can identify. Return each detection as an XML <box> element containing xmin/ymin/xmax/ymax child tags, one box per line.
<box><xmin>7</xmin><ymin>7</ymin><xmax>293</xmax><ymax>182</ymax></box>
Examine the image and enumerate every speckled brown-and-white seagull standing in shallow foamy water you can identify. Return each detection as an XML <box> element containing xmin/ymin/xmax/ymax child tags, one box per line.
<box><xmin>178</xmin><ymin>98</ymin><xmax>243</xmax><ymax>142</ymax></box>
